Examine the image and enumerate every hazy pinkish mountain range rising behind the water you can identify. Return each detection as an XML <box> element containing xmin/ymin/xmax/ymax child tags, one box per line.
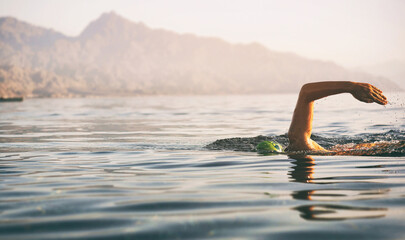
<box><xmin>0</xmin><ymin>12</ymin><xmax>398</xmax><ymax>97</ymax></box>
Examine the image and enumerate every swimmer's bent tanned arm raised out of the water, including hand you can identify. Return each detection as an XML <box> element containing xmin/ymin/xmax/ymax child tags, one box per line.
<box><xmin>288</xmin><ymin>82</ymin><xmax>387</xmax><ymax>151</ymax></box>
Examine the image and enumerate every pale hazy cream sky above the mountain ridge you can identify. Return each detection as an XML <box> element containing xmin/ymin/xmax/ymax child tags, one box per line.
<box><xmin>0</xmin><ymin>0</ymin><xmax>405</xmax><ymax>67</ymax></box>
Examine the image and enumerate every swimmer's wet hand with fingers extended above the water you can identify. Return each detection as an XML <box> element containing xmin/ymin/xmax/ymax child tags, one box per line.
<box><xmin>350</xmin><ymin>83</ymin><xmax>388</xmax><ymax>105</ymax></box>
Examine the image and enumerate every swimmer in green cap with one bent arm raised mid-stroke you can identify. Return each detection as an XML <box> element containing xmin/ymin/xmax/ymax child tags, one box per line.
<box><xmin>206</xmin><ymin>82</ymin><xmax>392</xmax><ymax>155</ymax></box>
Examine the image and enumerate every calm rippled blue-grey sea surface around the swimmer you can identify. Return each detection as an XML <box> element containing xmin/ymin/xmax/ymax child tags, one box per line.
<box><xmin>0</xmin><ymin>93</ymin><xmax>405</xmax><ymax>240</ymax></box>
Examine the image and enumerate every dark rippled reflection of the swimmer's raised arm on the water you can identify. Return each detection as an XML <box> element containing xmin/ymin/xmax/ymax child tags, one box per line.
<box><xmin>289</xmin><ymin>155</ymin><xmax>389</xmax><ymax>221</ymax></box>
